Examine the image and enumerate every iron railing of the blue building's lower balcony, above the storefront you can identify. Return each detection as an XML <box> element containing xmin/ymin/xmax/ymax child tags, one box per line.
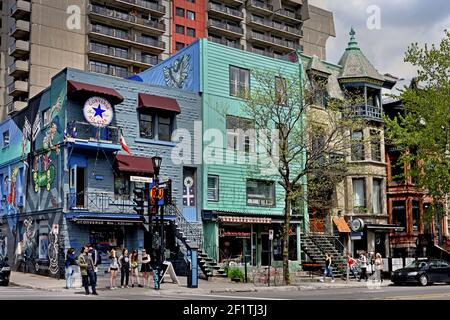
<box><xmin>67</xmin><ymin>191</ymin><xmax>136</xmax><ymax>214</ymax></box>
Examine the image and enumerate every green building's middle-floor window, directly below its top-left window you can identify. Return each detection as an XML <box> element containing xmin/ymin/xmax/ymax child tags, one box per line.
<box><xmin>226</xmin><ymin>115</ymin><xmax>255</xmax><ymax>153</ymax></box>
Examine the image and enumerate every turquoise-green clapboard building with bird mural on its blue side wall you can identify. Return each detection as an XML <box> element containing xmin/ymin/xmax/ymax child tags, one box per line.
<box><xmin>133</xmin><ymin>39</ymin><xmax>307</xmax><ymax>266</ymax></box>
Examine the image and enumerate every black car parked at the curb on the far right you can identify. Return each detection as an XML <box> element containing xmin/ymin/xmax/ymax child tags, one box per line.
<box><xmin>391</xmin><ymin>259</ymin><xmax>450</xmax><ymax>286</ymax></box>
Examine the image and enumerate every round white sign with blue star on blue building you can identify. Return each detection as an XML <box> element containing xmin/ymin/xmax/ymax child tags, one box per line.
<box><xmin>83</xmin><ymin>97</ymin><xmax>114</xmax><ymax>128</ymax></box>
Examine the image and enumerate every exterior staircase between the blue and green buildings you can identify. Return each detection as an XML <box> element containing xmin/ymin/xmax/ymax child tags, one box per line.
<box><xmin>166</xmin><ymin>205</ymin><xmax>226</xmax><ymax>280</ymax></box>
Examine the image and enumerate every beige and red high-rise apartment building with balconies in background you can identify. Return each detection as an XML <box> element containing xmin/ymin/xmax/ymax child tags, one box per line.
<box><xmin>0</xmin><ymin>0</ymin><xmax>334</xmax><ymax>119</ymax></box>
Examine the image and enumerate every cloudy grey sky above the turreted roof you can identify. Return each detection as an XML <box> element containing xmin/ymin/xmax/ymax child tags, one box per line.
<box><xmin>309</xmin><ymin>0</ymin><xmax>450</xmax><ymax>88</ymax></box>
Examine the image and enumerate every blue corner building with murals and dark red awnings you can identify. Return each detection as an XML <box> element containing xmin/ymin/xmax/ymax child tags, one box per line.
<box><xmin>0</xmin><ymin>69</ymin><xmax>201</xmax><ymax>277</ymax></box>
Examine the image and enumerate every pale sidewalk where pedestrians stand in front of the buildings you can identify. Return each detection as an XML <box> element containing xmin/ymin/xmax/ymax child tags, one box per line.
<box><xmin>10</xmin><ymin>272</ymin><xmax>391</xmax><ymax>294</ymax></box>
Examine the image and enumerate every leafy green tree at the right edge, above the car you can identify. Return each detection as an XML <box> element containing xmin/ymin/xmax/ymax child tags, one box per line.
<box><xmin>385</xmin><ymin>30</ymin><xmax>450</xmax><ymax>225</ymax></box>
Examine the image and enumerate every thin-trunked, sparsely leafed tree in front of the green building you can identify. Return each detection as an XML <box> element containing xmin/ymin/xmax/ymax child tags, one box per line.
<box><xmin>243</xmin><ymin>65</ymin><xmax>362</xmax><ymax>284</ymax></box>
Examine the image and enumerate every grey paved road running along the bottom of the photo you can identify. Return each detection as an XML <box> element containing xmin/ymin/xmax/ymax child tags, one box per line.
<box><xmin>0</xmin><ymin>285</ymin><xmax>450</xmax><ymax>301</ymax></box>
